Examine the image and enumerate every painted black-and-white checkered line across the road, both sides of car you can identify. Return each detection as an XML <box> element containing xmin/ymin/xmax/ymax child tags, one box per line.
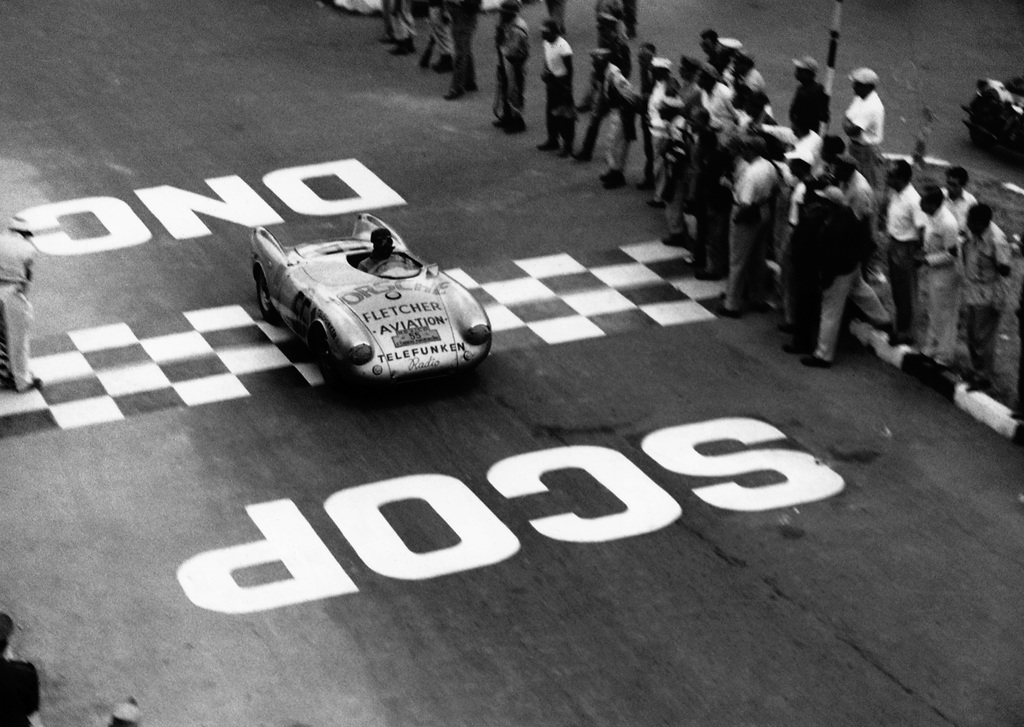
<box><xmin>0</xmin><ymin>242</ymin><xmax>722</xmax><ymax>437</ymax></box>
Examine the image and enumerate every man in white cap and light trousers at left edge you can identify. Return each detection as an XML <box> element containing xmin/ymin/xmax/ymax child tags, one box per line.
<box><xmin>0</xmin><ymin>217</ymin><xmax>42</xmax><ymax>391</ymax></box>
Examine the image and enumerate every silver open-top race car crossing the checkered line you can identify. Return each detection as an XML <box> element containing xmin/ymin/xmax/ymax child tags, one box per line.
<box><xmin>251</xmin><ymin>214</ymin><xmax>490</xmax><ymax>383</ymax></box>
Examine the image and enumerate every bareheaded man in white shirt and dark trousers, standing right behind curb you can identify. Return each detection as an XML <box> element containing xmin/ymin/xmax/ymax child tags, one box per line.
<box><xmin>886</xmin><ymin>159</ymin><xmax>921</xmax><ymax>344</ymax></box>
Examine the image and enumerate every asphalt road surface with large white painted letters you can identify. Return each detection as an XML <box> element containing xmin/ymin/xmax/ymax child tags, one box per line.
<box><xmin>0</xmin><ymin>0</ymin><xmax>1024</xmax><ymax>727</ymax></box>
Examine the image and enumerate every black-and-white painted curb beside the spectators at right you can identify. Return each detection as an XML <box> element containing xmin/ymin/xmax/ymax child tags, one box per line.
<box><xmin>850</xmin><ymin>320</ymin><xmax>1024</xmax><ymax>444</ymax></box>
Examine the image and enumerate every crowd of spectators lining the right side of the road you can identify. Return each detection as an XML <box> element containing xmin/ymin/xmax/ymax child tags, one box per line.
<box><xmin>372</xmin><ymin>0</ymin><xmax>1024</xmax><ymax>418</ymax></box>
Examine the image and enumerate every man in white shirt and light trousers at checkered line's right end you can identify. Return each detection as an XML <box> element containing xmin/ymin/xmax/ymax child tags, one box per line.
<box><xmin>718</xmin><ymin>137</ymin><xmax>779</xmax><ymax>318</ymax></box>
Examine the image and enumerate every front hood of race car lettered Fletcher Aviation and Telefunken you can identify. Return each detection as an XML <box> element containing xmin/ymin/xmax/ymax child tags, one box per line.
<box><xmin>337</xmin><ymin>271</ymin><xmax>465</xmax><ymax>379</ymax></box>
